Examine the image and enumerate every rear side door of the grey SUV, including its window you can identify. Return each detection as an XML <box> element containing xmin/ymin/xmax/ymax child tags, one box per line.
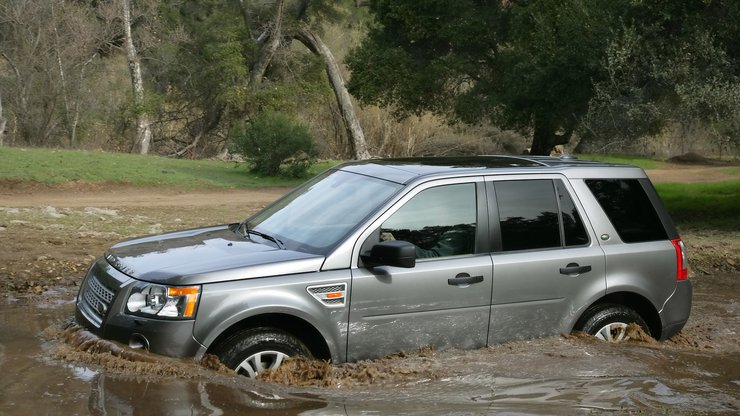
<box><xmin>488</xmin><ymin>176</ymin><xmax>606</xmax><ymax>343</ymax></box>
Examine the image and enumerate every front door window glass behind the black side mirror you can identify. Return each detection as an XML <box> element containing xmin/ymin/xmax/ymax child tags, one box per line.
<box><xmin>380</xmin><ymin>183</ymin><xmax>477</xmax><ymax>258</ymax></box>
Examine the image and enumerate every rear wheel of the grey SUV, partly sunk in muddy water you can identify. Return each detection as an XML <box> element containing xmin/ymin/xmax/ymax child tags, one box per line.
<box><xmin>575</xmin><ymin>303</ymin><xmax>651</xmax><ymax>342</ymax></box>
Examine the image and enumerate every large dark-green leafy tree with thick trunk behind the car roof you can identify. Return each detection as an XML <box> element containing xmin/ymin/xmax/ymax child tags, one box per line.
<box><xmin>348</xmin><ymin>0</ymin><xmax>622</xmax><ymax>154</ymax></box>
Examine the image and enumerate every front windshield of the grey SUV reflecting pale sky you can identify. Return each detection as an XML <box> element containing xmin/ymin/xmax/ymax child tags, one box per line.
<box><xmin>247</xmin><ymin>171</ymin><xmax>401</xmax><ymax>254</ymax></box>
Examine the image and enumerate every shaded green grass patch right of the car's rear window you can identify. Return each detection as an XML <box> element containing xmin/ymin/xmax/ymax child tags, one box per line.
<box><xmin>655</xmin><ymin>180</ymin><xmax>740</xmax><ymax>231</ymax></box>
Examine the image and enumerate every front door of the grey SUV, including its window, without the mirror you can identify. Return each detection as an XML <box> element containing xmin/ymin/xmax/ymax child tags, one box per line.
<box><xmin>347</xmin><ymin>178</ymin><xmax>492</xmax><ymax>361</ymax></box>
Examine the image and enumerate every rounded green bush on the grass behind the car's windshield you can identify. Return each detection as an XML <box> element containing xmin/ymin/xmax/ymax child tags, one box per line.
<box><xmin>230</xmin><ymin>112</ymin><xmax>315</xmax><ymax>178</ymax></box>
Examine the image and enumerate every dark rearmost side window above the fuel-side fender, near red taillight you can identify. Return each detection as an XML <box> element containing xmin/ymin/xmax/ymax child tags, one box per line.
<box><xmin>586</xmin><ymin>179</ymin><xmax>668</xmax><ymax>243</ymax></box>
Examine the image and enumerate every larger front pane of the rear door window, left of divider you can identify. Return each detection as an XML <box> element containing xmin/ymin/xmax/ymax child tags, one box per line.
<box><xmin>495</xmin><ymin>180</ymin><xmax>561</xmax><ymax>251</ymax></box>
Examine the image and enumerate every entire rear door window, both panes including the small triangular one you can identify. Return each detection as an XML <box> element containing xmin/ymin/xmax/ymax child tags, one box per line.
<box><xmin>494</xmin><ymin>179</ymin><xmax>589</xmax><ymax>251</ymax></box>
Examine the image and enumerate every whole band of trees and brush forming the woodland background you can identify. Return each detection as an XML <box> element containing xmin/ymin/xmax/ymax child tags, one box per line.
<box><xmin>0</xmin><ymin>0</ymin><xmax>740</xmax><ymax>169</ymax></box>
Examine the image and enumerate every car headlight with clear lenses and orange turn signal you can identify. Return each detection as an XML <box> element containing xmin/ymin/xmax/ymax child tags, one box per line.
<box><xmin>126</xmin><ymin>284</ymin><xmax>200</xmax><ymax>319</ymax></box>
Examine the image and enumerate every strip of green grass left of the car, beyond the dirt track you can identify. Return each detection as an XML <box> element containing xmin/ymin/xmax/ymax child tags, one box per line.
<box><xmin>0</xmin><ymin>147</ymin><xmax>337</xmax><ymax>189</ymax></box>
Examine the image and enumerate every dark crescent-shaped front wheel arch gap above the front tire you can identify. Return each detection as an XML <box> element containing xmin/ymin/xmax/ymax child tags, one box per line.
<box><xmin>206</xmin><ymin>313</ymin><xmax>332</xmax><ymax>361</ymax></box>
